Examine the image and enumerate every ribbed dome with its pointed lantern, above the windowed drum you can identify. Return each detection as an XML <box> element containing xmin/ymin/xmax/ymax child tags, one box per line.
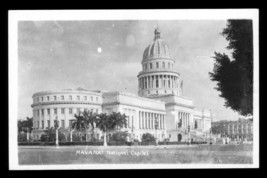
<box><xmin>143</xmin><ymin>28</ymin><xmax>171</xmax><ymax>62</ymax></box>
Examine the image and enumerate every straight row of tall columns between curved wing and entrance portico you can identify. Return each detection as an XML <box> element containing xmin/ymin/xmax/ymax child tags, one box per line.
<box><xmin>139</xmin><ymin>111</ymin><xmax>165</xmax><ymax>129</ymax></box>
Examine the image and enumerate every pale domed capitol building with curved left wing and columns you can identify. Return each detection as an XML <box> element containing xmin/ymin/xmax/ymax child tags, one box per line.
<box><xmin>31</xmin><ymin>28</ymin><xmax>212</xmax><ymax>142</ymax></box>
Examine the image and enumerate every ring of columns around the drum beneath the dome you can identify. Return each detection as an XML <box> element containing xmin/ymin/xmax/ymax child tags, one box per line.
<box><xmin>138</xmin><ymin>75</ymin><xmax>179</xmax><ymax>90</ymax></box>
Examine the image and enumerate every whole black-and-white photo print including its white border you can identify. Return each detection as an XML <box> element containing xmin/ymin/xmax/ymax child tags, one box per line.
<box><xmin>8</xmin><ymin>9</ymin><xmax>259</xmax><ymax>170</ymax></box>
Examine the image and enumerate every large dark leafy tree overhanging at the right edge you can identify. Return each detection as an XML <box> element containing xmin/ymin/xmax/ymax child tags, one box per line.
<box><xmin>209</xmin><ymin>20</ymin><xmax>253</xmax><ymax>115</ymax></box>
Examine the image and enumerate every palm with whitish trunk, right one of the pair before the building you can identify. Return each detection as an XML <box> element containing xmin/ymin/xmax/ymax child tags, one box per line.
<box><xmin>96</xmin><ymin>112</ymin><xmax>127</xmax><ymax>146</ymax></box>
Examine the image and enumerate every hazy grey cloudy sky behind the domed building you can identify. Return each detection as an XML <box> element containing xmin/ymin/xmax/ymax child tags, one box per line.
<box><xmin>18</xmin><ymin>20</ymin><xmax>242</xmax><ymax>121</ymax></box>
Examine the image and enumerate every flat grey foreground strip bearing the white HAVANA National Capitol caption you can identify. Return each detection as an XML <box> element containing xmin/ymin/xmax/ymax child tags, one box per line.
<box><xmin>19</xmin><ymin>145</ymin><xmax>252</xmax><ymax>165</ymax></box>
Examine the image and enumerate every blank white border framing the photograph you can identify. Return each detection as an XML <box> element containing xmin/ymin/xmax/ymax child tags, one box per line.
<box><xmin>8</xmin><ymin>9</ymin><xmax>259</xmax><ymax>170</ymax></box>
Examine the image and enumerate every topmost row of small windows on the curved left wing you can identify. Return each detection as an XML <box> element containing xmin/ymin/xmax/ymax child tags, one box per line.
<box><xmin>36</xmin><ymin>95</ymin><xmax>98</xmax><ymax>102</ymax></box>
